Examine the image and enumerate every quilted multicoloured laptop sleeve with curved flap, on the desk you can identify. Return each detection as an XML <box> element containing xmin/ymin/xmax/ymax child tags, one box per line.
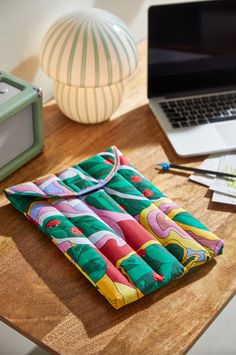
<box><xmin>5</xmin><ymin>147</ymin><xmax>223</xmax><ymax>308</ymax></box>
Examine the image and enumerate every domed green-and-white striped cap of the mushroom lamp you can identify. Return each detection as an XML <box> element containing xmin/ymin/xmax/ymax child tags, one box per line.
<box><xmin>40</xmin><ymin>8</ymin><xmax>137</xmax><ymax>87</ymax></box>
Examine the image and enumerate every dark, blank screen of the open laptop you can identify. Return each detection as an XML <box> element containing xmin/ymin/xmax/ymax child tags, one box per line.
<box><xmin>148</xmin><ymin>0</ymin><xmax>236</xmax><ymax>98</ymax></box>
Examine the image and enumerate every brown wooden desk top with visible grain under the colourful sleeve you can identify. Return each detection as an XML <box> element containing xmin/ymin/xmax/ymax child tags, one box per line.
<box><xmin>0</xmin><ymin>44</ymin><xmax>236</xmax><ymax>355</ymax></box>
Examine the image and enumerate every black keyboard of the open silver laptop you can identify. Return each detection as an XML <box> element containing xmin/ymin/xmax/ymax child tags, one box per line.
<box><xmin>160</xmin><ymin>93</ymin><xmax>236</xmax><ymax>128</ymax></box>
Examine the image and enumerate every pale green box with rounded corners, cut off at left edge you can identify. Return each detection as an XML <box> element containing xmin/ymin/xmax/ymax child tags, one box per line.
<box><xmin>0</xmin><ymin>72</ymin><xmax>44</xmax><ymax>181</ymax></box>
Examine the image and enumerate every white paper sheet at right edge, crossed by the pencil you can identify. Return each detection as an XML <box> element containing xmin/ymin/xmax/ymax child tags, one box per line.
<box><xmin>210</xmin><ymin>153</ymin><xmax>236</xmax><ymax>197</ymax></box>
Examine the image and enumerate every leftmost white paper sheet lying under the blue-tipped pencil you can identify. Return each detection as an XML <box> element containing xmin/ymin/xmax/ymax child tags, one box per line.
<box><xmin>189</xmin><ymin>154</ymin><xmax>221</xmax><ymax>186</ymax></box>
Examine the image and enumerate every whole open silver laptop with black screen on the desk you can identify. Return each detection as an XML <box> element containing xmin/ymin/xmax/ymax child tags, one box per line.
<box><xmin>148</xmin><ymin>0</ymin><xmax>236</xmax><ymax>157</ymax></box>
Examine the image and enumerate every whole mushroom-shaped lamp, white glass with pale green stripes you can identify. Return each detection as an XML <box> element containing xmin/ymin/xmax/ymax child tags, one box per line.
<box><xmin>40</xmin><ymin>8</ymin><xmax>137</xmax><ymax>123</ymax></box>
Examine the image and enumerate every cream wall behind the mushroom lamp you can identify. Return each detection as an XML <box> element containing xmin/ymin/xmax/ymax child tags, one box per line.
<box><xmin>0</xmin><ymin>0</ymin><xmax>206</xmax><ymax>101</ymax></box>
